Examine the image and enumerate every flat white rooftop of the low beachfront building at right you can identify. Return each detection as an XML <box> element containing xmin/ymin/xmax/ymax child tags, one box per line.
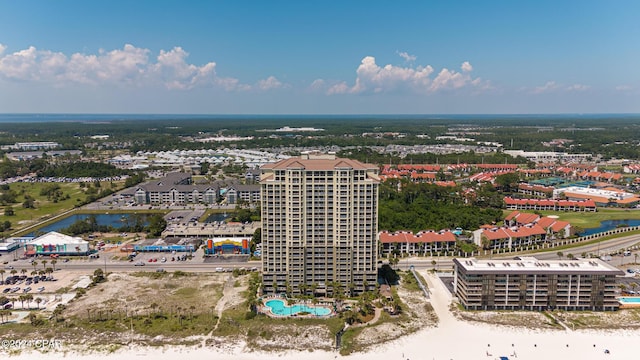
<box><xmin>453</xmin><ymin>257</ymin><xmax>624</xmax><ymax>275</ymax></box>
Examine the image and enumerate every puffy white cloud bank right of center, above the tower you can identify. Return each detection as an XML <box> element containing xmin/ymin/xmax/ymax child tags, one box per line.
<box><xmin>328</xmin><ymin>56</ymin><xmax>488</xmax><ymax>95</ymax></box>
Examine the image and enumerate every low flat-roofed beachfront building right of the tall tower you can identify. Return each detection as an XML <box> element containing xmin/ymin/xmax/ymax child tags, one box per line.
<box><xmin>453</xmin><ymin>257</ymin><xmax>624</xmax><ymax>311</ymax></box>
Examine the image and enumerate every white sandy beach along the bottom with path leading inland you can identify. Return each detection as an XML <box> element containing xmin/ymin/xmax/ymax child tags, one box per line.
<box><xmin>0</xmin><ymin>272</ymin><xmax>640</xmax><ymax>360</ymax></box>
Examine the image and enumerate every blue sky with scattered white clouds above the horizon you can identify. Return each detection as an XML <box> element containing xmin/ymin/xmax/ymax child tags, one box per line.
<box><xmin>0</xmin><ymin>0</ymin><xmax>640</xmax><ymax>114</ymax></box>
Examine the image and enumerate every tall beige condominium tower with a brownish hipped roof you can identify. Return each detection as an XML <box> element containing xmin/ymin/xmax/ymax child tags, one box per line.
<box><xmin>260</xmin><ymin>153</ymin><xmax>379</xmax><ymax>296</ymax></box>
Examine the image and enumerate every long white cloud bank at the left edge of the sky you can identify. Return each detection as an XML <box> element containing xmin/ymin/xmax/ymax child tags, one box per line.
<box><xmin>0</xmin><ymin>44</ymin><xmax>278</xmax><ymax>91</ymax></box>
